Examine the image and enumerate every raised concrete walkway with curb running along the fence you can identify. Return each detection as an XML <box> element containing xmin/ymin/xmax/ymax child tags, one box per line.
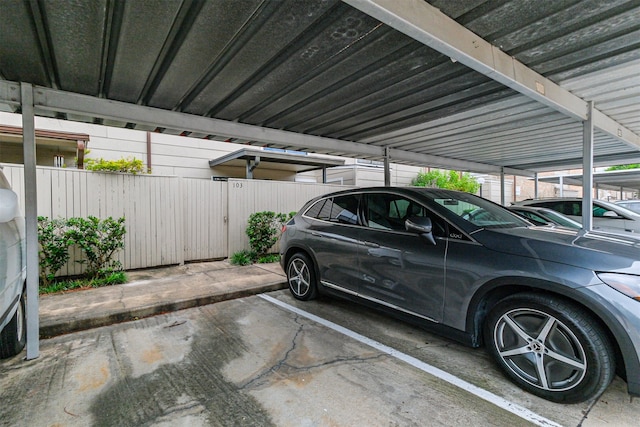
<box><xmin>40</xmin><ymin>260</ymin><xmax>286</xmax><ymax>338</ymax></box>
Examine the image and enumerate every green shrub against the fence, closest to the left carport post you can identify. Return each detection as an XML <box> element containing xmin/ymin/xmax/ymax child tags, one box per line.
<box><xmin>38</xmin><ymin>216</ymin><xmax>69</xmax><ymax>286</ymax></box>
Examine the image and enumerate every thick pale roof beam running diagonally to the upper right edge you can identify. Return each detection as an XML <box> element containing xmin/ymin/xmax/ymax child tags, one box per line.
<box><xmin>343</xmin><ymin>0</ymin><xmax>640</xmax><ymax>148</ymax></box>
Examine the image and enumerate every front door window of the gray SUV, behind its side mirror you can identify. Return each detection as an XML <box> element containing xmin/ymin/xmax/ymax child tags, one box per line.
<box><xmin>364</xmin><ymin>193</ymin><xmax>446</xmax><ymax>237</ymax></box>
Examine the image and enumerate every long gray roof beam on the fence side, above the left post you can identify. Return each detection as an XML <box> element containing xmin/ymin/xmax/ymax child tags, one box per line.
<box><xmin>0</xmin><ymin>80</ymin><xmax>520</xmax><ymax>176</ymax></box>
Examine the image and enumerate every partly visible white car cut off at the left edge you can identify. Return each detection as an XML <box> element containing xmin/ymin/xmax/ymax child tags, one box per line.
<box><xmin>0</xmin><ymin>166</ymin><xmax>26</xmax><ymax>358</ymax></box>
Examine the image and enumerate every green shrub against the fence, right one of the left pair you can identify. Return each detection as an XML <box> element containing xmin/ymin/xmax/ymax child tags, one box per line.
<box><xmin>67</xmin><ymin>216</ymin><xmax>126</xmax><ymax>279</ymax></box>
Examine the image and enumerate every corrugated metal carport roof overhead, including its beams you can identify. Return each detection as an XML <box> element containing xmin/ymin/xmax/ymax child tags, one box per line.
<box><xmin>0</xmin><ymin>0</ymin><xmax>640</xmax><ymax>174</ymax></box>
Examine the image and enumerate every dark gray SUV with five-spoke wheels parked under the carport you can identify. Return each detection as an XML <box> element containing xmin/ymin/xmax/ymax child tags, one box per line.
<box><xmin>280</xmin><ymin>187</ymin><xmax>640</xmax><ymax>403</ymax></box>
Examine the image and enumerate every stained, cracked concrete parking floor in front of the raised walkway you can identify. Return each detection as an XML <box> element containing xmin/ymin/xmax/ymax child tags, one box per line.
<box><xmin>0</xmin><ymin>291</ymin><xmax>640</xmax><ymax>426</ymax></box>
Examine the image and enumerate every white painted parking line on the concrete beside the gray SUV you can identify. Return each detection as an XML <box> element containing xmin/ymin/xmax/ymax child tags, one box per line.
<box><xmin>258</xmin><ymin>294</ymin><xmax>560</xmax><ymax>427</ymax></box>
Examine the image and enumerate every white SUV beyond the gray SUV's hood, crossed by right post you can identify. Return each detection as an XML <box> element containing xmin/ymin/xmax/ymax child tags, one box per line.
<box><xmin>513</xmin><ymin>197</ymin><xmax>640</xmax><ymax>233</ymax></box>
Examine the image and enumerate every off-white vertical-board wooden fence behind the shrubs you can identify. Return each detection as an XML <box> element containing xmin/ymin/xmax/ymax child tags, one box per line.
<box><xmin>3</xmin><ymin>164</ymin><xmax>345</xmax><ymax>276</ymax></box>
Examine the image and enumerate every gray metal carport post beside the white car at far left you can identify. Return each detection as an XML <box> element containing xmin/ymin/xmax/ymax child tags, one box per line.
<box><xmin>20</xmin><ymin>83</ymin><xmax>40</xmax><ymax>360</ymax></box>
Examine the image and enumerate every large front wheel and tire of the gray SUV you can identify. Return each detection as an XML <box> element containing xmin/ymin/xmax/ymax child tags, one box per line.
<box><xmin>484</xmin><ymin>294</ymin><xmax>615</xmax><ymax>403</ymax></box>
